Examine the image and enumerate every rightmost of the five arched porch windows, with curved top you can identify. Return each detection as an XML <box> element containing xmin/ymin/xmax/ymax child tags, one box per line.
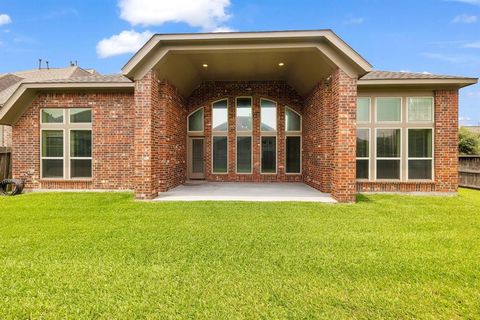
<box><xmin>285</xmin><ymin>107</ymin><xmax>302</xmax><ymax>174</ymax></box>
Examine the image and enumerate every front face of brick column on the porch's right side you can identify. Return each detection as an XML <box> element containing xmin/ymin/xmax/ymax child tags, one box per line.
<box><xmin>330</xmin><ymin>69</ymin><xmax>357</xmax><ymax>202</ymax></box>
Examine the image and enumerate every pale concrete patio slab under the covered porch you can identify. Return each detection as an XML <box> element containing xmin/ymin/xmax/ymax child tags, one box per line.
<box><xmin>154</xmin><ymin>181</ymin><xmax>337</xmax><ymax>203</ymax></box>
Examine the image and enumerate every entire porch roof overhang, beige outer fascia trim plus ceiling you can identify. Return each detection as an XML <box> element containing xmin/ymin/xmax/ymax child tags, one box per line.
<box><xmin>122</xmin><ymin>30</ymin><xmax>371</xmax><ymax>96</ymax></box>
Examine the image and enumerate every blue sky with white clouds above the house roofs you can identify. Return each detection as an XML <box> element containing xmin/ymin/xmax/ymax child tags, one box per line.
<box><xmin>0</xmin><ymin>0</ymin><xmax>480</xmax><ymax>124</ymax></box>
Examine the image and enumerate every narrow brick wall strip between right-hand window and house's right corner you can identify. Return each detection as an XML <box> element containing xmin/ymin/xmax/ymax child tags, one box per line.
<box><xmin>434</xmin><ymin>89</ymin><xmax>458</xmax><ymax>192</ymax></box>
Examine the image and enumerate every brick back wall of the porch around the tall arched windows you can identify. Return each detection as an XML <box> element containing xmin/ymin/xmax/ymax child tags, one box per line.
<box><xmin>188</xmin><ymin>81</ymin><xmax>303</xmax><ymax>182</ymax></box>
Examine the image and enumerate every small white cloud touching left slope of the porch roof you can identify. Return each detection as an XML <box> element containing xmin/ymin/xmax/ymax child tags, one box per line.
<box><xmin>97</xmin><ymin>30</ymin><xmax>153</xmax><ymax>58</ymax></box>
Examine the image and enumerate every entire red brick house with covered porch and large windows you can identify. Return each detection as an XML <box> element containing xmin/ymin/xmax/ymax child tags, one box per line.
<box><xmin>0</xmin><ymin>30</ymin><xmax>477</xmax><ymax>202</ymax></box>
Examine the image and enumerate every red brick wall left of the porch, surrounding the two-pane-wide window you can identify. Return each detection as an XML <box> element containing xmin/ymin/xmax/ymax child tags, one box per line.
<box><xmin>12</xmin><ymin>92</ymin><xmax>134</xmax><ymax>189</ymax></box>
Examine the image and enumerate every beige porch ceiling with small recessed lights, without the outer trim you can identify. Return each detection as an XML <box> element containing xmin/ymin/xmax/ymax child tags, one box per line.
<box><xmin>155</xmin><ymin>48</ymin><xmax>336</xmax><ymax>96</ymax></box>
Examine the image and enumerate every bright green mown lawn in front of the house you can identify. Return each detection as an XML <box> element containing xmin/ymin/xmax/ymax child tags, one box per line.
<box><xmin>0</xmin><ymin>190</ymin><xmax>480</xmax><ymax>319</ymax></box>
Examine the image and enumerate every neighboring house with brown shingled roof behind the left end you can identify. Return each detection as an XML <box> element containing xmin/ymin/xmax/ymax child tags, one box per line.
<box><xmin>0</xmin><ymin>66</ymin><xmax>96</xmax><ymax>147</ymax></box>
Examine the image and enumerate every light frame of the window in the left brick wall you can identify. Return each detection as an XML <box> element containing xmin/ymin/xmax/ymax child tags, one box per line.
<box><xmin>39</xmin><ymin>107</ymin><xmax>94</xmax><ymax>181</ymax></box>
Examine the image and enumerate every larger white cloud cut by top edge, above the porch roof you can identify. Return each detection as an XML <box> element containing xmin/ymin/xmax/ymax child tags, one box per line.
<box><xmin>118</xmin><ymin>0</ymin><xmax>230</xmax><ymax>31</ymax></box>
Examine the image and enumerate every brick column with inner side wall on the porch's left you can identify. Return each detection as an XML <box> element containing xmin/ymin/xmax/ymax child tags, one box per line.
<box><xmin>134</xmin><ymin>71</ymin><xmax>187</xmax><ymax>199</ymax></box>
